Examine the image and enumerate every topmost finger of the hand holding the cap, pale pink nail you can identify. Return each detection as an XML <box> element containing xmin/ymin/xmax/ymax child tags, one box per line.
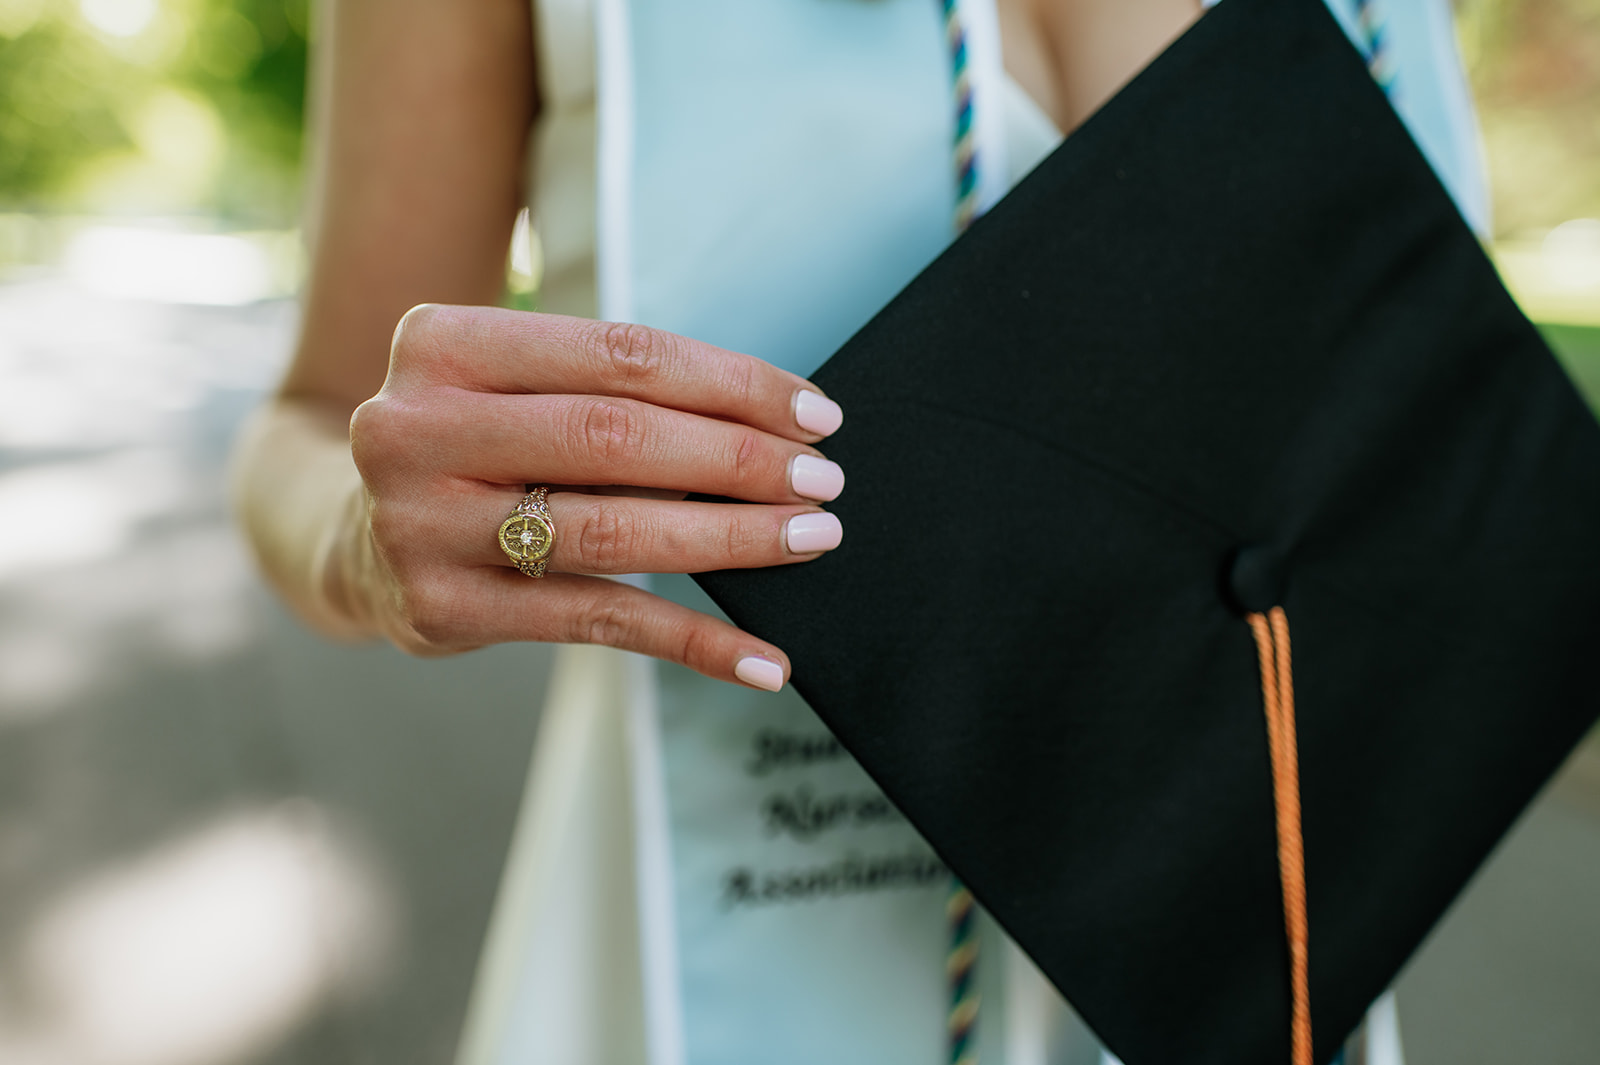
<box><xmin>394</xmin><ymin>304</ymin><xmax>843</xmax><ymax>443</ymax></box>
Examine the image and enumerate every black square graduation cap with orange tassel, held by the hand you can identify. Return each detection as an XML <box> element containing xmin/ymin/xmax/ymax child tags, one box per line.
<box><xmin>701</xmin><ymin>0</ymin><xmax>1600</xmax><ymax>1065</ymax></box>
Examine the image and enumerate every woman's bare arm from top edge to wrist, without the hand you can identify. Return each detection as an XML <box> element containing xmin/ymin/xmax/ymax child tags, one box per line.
<box><xmin>235</xmin><ymin>0</ymin><xmax>536</xmax><ymax>636</ymax></box>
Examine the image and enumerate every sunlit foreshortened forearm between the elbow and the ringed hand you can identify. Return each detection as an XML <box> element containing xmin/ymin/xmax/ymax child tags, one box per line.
<box><xmin>232</xmin><ymin>391</ymin><xmax>378</xmax><ymax>640</ymax></box>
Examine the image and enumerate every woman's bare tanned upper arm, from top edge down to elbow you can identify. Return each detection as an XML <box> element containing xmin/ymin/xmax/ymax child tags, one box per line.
<box><xmin>283</xmin><ymin>0</ymin><xmax>536</xmax><ymax>406</ymax></box>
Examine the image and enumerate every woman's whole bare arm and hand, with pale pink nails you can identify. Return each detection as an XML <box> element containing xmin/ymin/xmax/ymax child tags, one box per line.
<box><xmin>234</xmin><ymin>0</ymin><xmax>842</xmax><ymax>688</ymax></box>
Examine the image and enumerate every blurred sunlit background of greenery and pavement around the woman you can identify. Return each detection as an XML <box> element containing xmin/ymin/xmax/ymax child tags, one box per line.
<box><xmin>0</xmin><ymin>0</ymin><xmax>1600</xmax><ymax>1065</ymax></box>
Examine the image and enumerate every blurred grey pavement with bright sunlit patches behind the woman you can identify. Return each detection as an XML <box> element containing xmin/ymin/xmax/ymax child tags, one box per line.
<box><xmin>0</xmin><ymin>265</ymin><xmax>1600</xmax><ymax>1065</ymax></box>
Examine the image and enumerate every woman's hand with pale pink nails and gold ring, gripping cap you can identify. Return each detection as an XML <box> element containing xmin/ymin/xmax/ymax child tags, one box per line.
<box><xmin>342</xmin><ymin>305</ymin><xmax>845</xmax><ymax>689</ymax></box>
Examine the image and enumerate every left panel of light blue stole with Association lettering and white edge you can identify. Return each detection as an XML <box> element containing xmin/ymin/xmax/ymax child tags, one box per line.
<box><xmin>600</xmin><ymin>0</ymin><xmax>1002</xmax><ymax>1065</ymax></box>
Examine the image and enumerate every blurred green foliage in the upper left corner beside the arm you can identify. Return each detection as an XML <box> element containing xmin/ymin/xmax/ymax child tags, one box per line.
<box><xmin>0</xmin><ymin>0</ymin><xmax>309</xmax><ymax>225</ymax></box>
